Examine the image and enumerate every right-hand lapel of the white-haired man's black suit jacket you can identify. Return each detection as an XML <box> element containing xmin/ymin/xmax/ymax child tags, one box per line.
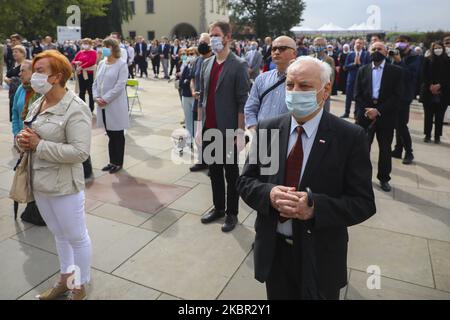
<box><xmin>300</xmin><ymin>112</ymin><xmax>333</xmax><ymax>190</ymax></box>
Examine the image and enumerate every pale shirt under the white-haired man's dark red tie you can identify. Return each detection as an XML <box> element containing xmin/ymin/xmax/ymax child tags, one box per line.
<box><xmin>277</xmin><ymin>109</ymin><xmax>324</xmax><ymax>237</ymax></box>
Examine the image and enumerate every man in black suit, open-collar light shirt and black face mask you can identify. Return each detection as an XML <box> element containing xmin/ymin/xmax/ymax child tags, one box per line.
<box><xmin>355</xmin><ymin>42</ymin><xmax>403</xmax><ymax>192</ymax></box>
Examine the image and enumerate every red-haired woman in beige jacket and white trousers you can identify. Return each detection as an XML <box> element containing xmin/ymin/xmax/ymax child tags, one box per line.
<box><xmin>16</xmin><ymin>50</ymin><xmax>92</xmax><ymax>300</ymax></box>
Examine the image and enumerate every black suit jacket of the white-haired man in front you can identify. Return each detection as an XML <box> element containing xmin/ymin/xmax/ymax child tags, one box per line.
<box><xmin>237</xmin><ymin>112</ymin><xmax>376</xmax><ymax>299</ymax></box>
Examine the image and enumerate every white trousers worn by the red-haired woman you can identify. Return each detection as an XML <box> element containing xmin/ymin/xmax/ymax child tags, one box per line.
<box><xmin>34</xmin><ymin>191</ymin><xmax>92</xmax><ymax>284</ymax></box>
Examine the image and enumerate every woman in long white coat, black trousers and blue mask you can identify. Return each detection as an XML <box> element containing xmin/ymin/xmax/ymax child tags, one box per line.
<box><xmin>92</xmin><ymin>38</ymin><xmax>130</xmax><ymax>174</ymax></box>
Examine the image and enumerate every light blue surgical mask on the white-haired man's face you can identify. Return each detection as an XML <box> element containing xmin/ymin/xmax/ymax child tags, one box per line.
<box><xmin>286</xmin><ymin>88</ymin><xmax>324</xmax><ymax>119</ymax></box>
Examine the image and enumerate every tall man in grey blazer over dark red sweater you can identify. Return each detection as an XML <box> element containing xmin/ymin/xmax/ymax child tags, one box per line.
<box><xmin>196</xmin><ymin>22</ymin><xmax>250</xmax><ymax>232</ymax></box>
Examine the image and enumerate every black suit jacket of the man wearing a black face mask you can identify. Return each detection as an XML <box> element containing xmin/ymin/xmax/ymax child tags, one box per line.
<box><xmin>354</xmin><ymin>62</ymin><xmax>403</xmax><ymax>123</ymax></box>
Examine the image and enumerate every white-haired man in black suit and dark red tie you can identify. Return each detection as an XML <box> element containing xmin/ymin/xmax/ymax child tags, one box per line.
<box><xmin>237</xmin><ymin>56</ymin><xmax>376</xmax><ymax>300</ymax></box>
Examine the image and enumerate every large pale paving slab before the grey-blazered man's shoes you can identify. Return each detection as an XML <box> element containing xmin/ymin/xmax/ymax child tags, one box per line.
<box><xmin>114</xmin><ymin>214</ymin><xmax>253</xmax><ymax>299</ymax></box>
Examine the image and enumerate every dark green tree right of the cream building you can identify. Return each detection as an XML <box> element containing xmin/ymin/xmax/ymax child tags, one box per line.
<box><xmin>229</xmin><ymin>0</ymin><xmax>306</xmax><ymax>38</ymax></box>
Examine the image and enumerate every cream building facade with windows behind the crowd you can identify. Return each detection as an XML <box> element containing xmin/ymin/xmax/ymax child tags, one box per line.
<box><xmin>122</xmin><ymin>0</ymin><xmax>229</xmax><ymax>40</ymax></box>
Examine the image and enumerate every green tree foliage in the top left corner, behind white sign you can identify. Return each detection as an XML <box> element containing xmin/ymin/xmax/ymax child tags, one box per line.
<box><xmin>0</xmin><ymin>0</ymin><xmax>111</xmax><ymax>39</ymax></box>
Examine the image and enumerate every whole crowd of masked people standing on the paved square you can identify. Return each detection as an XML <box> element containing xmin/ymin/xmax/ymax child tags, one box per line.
<box><xmin>0</xmin><ymin>21</ymin><xmax>450</xmax><ymax>300</ymax></box>
